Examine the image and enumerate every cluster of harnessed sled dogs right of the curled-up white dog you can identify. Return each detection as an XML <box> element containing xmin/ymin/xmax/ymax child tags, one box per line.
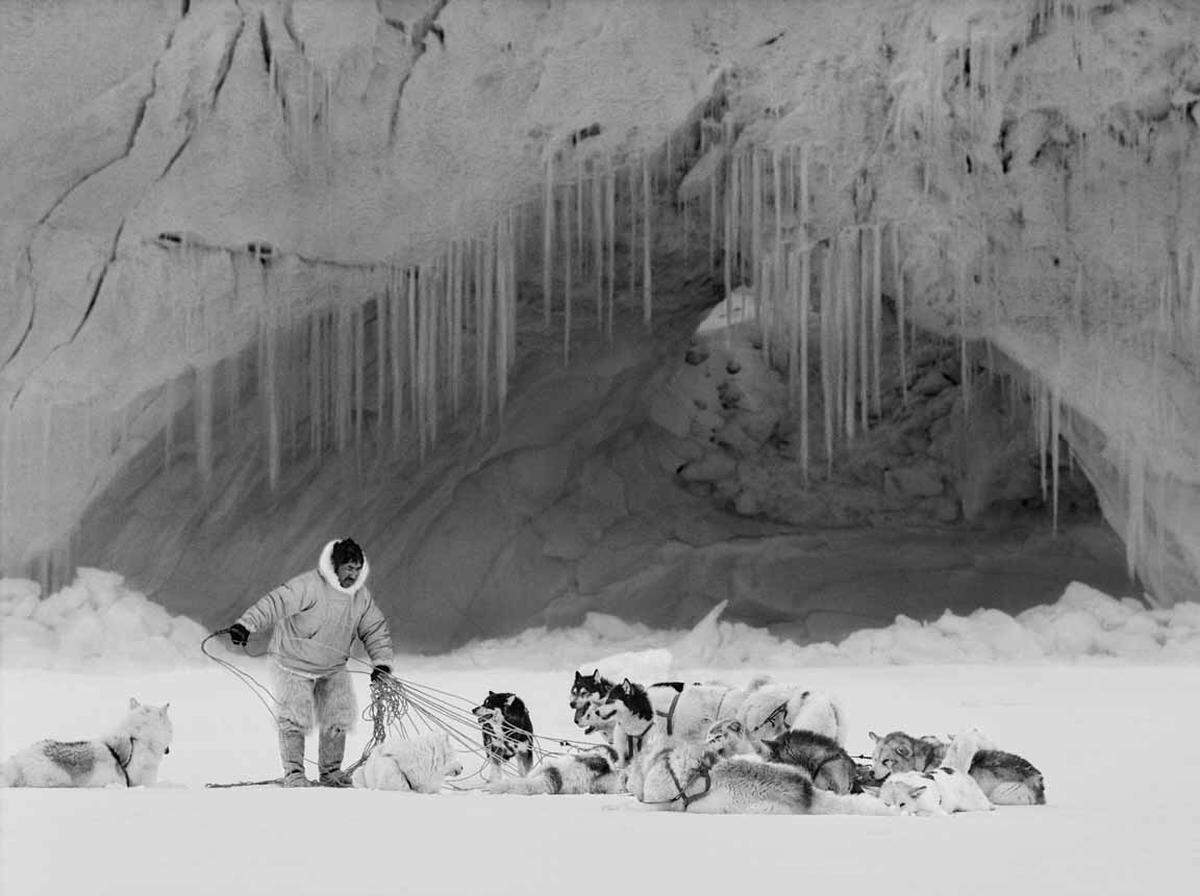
<box><xmin>476</xmin><ymin>672</ymin><xmax>1045</xmax><ymax>816</ymax></box>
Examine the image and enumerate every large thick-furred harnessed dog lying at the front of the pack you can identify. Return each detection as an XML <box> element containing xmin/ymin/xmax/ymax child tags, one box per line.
<box><xmin>635</xmin><ymin>720</ymin><xmax>896</xmax><ymax>816</ymax></box>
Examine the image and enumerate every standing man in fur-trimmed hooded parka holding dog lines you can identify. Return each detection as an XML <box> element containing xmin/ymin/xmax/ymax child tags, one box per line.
<box><xmin>228</xmin><ymin>539</ymin><xmax>392</xmax><ymax>787</ymax></box>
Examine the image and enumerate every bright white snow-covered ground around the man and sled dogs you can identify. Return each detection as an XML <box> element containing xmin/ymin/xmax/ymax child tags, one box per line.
<box><xmin>0</xmin><ymin>578</ymin><xmax>1200</xmax><ymax>896</ymax></box>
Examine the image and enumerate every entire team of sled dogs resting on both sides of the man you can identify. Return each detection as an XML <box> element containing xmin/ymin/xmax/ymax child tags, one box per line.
<box><xmin>0</xmin><ymin>672</ymin><xmax>1045</xmax><ymax>816</ymax></box>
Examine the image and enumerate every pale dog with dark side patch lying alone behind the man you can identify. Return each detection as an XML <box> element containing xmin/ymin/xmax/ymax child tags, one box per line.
<box><xmin>0</xmin><ymin>697</ymin><xmax>174</xmax><ymax>787</ymax></box>
